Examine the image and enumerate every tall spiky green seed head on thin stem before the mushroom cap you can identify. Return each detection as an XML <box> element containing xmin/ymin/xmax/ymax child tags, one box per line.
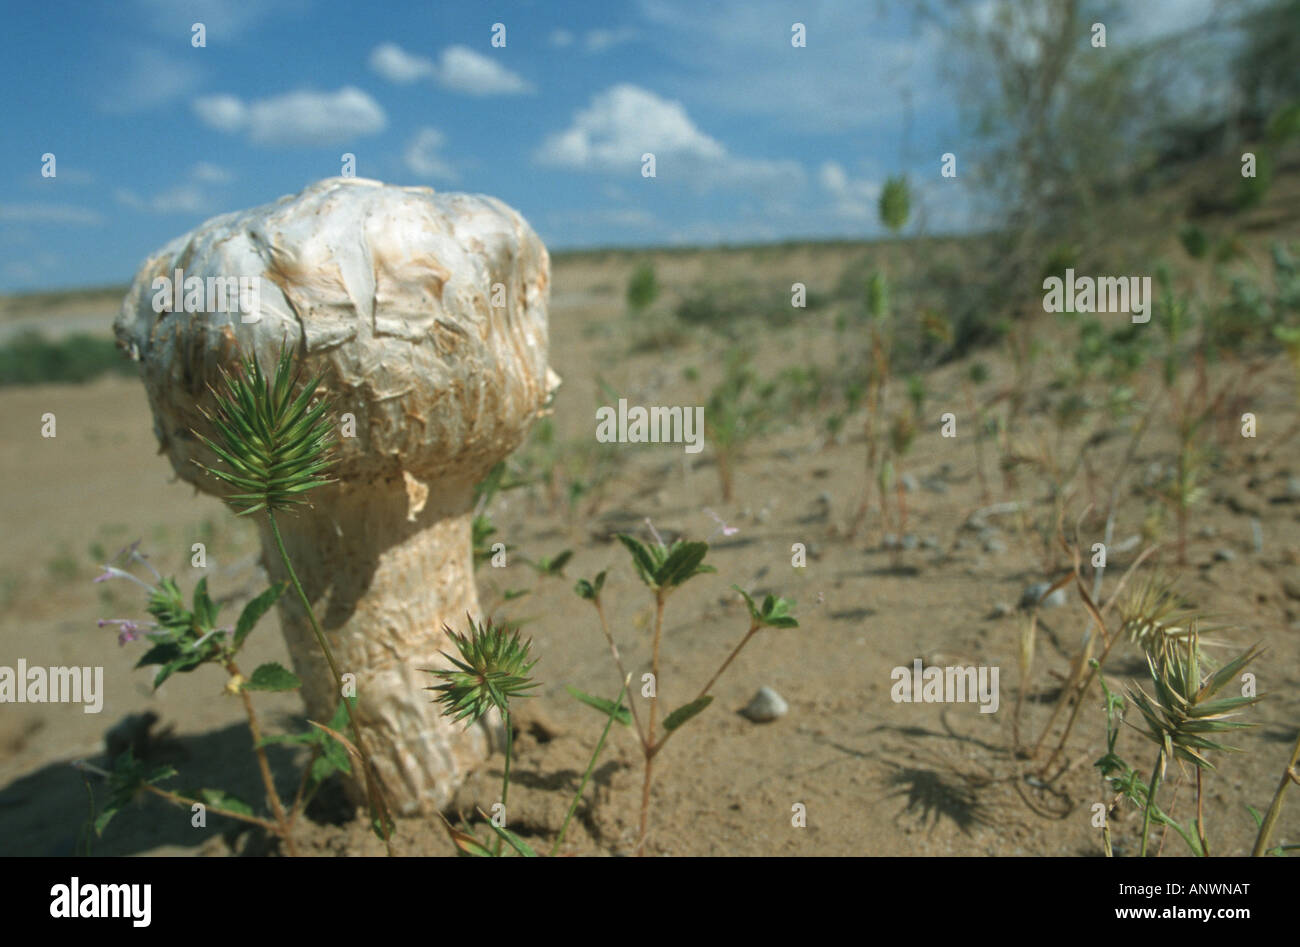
<box><xmin>194</xmin><ymin>343</ymin><xmax>393</xmax><ymax>855</ymax></box>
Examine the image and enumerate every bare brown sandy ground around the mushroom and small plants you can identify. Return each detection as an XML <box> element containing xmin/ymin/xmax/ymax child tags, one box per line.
<box><xmin>0</xmin><ymin>248</ymin><xmax>1300</xmax><ymax>856</ymax></box>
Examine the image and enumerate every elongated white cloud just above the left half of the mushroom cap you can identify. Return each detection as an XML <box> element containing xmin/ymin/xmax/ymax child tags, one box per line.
<box><xmin>194</xmin><ymin>86</ymin><xmax>387</xmax><ymax>146</ymax></box>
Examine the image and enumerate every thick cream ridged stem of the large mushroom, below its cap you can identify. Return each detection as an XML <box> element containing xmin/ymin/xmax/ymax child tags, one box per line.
<box><xmin>263</xmin><ymin>476</ymin><xmax>489</xmax><ymax>816</ymax></box>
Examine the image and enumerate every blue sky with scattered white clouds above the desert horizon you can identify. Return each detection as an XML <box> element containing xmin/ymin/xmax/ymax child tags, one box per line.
<box><xmin>0</xmin><ymin>0</ymin><xmax>1216</xmax><ymax>291</ymax></box>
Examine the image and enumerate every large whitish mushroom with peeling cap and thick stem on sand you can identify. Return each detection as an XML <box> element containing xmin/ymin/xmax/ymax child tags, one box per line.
<box><xmin>114</xmin><ymin>178</ymin><xmax>559</xmax><ymax>816</ymax></box>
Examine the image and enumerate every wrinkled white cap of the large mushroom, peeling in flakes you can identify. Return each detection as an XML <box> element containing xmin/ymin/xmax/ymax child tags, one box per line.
<box><xmin>114</xmin><ymin>178</ymin><xmax>558</xmax><ymax>489</ymax></box>
